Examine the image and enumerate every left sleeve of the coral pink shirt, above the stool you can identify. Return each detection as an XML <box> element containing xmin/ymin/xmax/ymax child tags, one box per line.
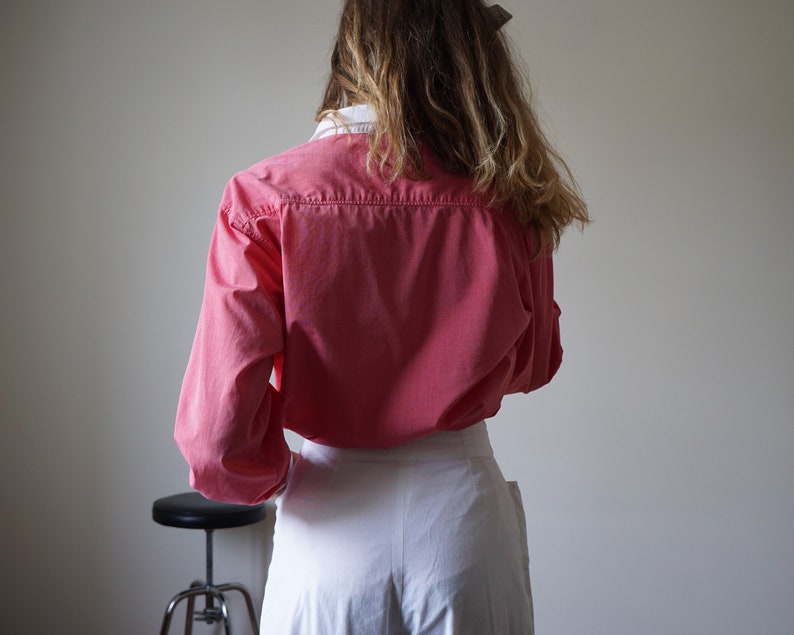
<box><xmin>174</xmin><ymin>180</ymin><xmax>290</xmax><ymax>504</ymax></box>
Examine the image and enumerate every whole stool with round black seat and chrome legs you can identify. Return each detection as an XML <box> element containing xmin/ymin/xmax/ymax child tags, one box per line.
<box><xmin>152</xmin><ymin>492</ymin><xmax>267</xmax><ymax>635</ymax></box>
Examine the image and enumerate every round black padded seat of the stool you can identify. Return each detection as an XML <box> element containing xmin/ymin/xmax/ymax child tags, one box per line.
<box><xmin>152</xmin><ymin>492</ymin><xmax>267</xmax><ymax>529</ymax></box>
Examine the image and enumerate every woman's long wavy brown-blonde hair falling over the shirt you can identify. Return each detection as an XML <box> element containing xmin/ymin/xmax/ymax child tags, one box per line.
<box><xmin>317</xmin><ymin>0</ymin><xmax>589</xmax><ymax>249</ymax></box>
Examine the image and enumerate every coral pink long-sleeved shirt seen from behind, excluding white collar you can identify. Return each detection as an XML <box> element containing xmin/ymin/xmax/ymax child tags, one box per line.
<box><xmin>175</xmin><ymin>110</ymin><xmax>562</xmax><ymax>504</ymax></box>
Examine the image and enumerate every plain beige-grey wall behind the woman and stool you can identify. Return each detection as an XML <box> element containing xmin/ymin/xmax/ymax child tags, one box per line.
<box><xmin>0</xmin><ymin>0</ymin><xmax>794</xmax><ymax>635</ymax></box>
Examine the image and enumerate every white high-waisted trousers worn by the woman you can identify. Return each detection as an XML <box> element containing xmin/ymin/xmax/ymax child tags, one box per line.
<box><xmin>260</xmin><ymin>422</ymin><xmax>533</xmax><ymax>635</ymax></box>
